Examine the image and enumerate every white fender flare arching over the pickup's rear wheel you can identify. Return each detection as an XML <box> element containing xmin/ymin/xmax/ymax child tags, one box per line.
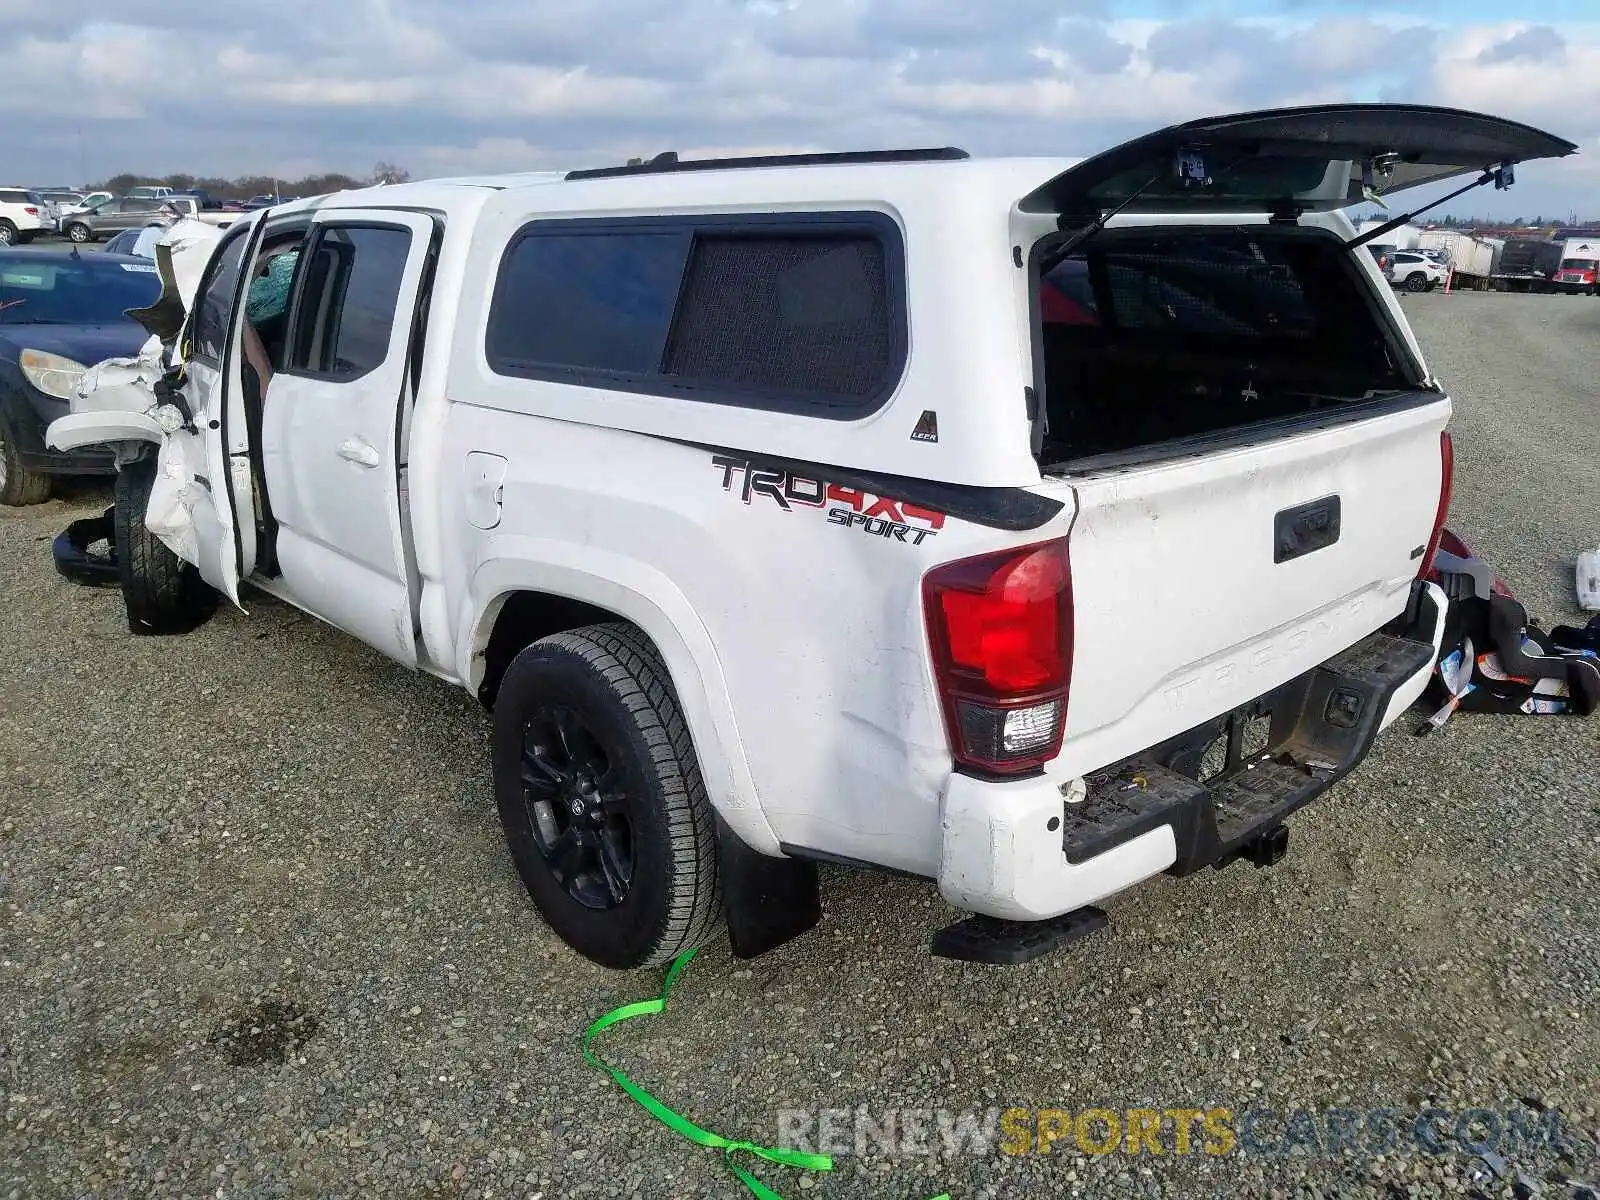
<box><xmin>456</xmin><ymin>550</ymin><xmax>779</xmax><ymax>854</ymax></box>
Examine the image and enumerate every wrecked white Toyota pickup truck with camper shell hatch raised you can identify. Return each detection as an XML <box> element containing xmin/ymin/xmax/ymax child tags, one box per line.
<box><xmin>51</xmin><ymin>106</ymin><xmax>1574</xmax><ymax>966</ymax></box>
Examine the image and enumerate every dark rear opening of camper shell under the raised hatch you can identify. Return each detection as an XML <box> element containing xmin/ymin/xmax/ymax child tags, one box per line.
<box><xmin>1034</xmin><ymin>224</ymin><xmax>1432</xmax><ymax>470</ymax></box>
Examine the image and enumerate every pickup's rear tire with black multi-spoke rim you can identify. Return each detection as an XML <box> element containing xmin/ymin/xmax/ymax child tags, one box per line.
<box><xmin>493</xmin><ymin>624</ymin><xmax>722</xmax><ymax>970</ymax></box>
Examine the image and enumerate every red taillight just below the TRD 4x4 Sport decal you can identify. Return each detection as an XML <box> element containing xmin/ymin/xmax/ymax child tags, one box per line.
<box><xmin>922</xmin><ymin>538</ymin><xmax>1072</xmax><ymax>774</ymax></box>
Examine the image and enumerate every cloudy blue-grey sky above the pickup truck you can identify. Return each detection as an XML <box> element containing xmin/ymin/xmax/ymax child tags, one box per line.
<box><xmin>9</xmin><ymin>0</ymin><xmax>1600</xmax><ymax>218</ymax></box>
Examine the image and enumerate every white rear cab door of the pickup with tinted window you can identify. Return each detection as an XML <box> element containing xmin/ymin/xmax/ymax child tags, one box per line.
<box><xmin>261</xmin><ymin>208</ymin><xmax>442</xmax><ymax>666</ymax></box>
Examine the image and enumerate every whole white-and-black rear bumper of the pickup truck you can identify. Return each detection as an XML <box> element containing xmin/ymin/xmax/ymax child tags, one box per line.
<box><xmin>939</xmin><ymin>584</ymin><xmax>1448</xmax><ymax>920</ymax></box>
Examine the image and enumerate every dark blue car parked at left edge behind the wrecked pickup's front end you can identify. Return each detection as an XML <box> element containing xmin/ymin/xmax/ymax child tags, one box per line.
<box><xmin>0</xmin><ymin>250</ymin><xmax>162</xmax><ymax>504</ymax></box>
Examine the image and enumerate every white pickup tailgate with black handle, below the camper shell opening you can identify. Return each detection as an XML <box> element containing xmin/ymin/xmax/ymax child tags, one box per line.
<box><xmin>1043</xmin><ymin>397</ymin><xmax>1450</xmax><ymax>774</ymax></box>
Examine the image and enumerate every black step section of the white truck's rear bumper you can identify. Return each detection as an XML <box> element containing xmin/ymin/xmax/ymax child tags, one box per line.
<box><xmin>1061</xmin><ymin>634</ymin><xmax>1434</xmax><ymax>875</ymax></box>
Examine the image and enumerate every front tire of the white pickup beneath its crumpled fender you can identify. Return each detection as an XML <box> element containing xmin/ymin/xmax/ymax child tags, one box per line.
<box><xmin>115</xmin><ymin>456</ymin><xmax>216</xmax><ymax>635</ymax></box>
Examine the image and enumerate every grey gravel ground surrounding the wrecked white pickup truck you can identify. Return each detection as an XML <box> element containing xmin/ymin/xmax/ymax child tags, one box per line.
<box><xmin>0</xmin><ymin>294</ymin><xmax>1600</xmax><ymax>1200</ymax></box>
